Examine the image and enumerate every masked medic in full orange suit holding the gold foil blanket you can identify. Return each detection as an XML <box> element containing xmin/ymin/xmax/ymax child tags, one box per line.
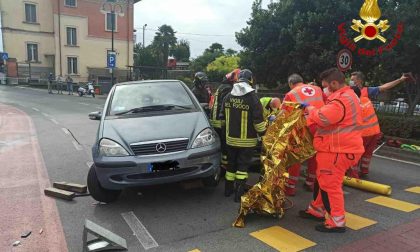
<box><xmin>299</xmin><ymin>68</ymin><xmax>364</xmax><ymax>233</ymax></box>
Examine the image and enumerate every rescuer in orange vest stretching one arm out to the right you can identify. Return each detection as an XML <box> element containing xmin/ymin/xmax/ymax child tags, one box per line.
<box><xmin>350</xmin><ymin>72</ymin><xmax>410</xmax><ymax>177</ymax></box>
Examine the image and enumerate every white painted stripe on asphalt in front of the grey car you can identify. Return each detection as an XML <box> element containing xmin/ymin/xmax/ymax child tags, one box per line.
<box><xmin>121</xmin><ymin>212</ymin><xmax>159</xmax><ymax>250</ymax></box>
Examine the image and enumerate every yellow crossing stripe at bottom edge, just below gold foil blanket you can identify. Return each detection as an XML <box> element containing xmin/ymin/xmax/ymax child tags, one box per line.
<box><xmin>250</xmin><ymin>226</ymin><xmax>316</xmax><ymax>252</ymax></box>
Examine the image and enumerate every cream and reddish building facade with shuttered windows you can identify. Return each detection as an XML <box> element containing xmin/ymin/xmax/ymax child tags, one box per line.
<box><xmin>0</xmin><ymin>0</ymin><xmax>138</xmax><ymax>83</ymax></box>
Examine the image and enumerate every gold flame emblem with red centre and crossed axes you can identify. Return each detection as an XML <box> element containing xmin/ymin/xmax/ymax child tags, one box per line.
<box><xmin>351</xmin><ymin>0</ymin><xmax>390</xmax><ymax>43</ymax></box>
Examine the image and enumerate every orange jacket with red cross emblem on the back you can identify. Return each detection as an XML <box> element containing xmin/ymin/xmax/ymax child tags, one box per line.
<box><xmin>283</xmin><ymin>83</ymin><xmax>324</xmax><ymax>126</ymax></box>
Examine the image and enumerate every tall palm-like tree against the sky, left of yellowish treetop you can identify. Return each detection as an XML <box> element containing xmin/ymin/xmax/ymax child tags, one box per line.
<box><xmin>152</xmin><ymin>25</ymin><xmax>177</xmax><ymax>66</ymax></box>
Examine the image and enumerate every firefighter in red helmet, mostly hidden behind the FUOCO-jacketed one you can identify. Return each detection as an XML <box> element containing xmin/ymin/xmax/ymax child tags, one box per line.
<box><xmin>210</xmin><ymin>69</ymin><xmax>241</xmax><ymax>169</ymax></box>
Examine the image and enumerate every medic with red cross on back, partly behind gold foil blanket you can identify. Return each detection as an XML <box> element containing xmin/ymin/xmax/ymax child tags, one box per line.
<box><xmin>283</xmin><ymin>74</ymin><xmax>324</xmax><ymax>196</ymax></box>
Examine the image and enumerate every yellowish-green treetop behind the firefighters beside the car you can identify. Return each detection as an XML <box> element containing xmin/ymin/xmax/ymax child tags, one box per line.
<box><xmin>206</xmin><ymin>56</ymin><xmax>240</xmax><ymax>81</ymax></box>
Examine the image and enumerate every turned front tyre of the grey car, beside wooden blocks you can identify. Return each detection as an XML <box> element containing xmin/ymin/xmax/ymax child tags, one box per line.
<box><xmin>87</xmin><ymin>164</ymin><xmax>121</xmax><ymax>203</ymax></box>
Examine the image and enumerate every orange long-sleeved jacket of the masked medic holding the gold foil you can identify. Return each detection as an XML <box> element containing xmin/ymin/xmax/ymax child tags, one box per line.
<box><xmin>309</xmin><ymin>86</ymin><xmax>365</xmax><ymax>154</ymax></box>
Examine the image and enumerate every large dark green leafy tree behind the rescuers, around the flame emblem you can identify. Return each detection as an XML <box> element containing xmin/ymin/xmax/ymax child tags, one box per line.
<box><xmin>236</xmin><ymin>0</ymin><xmax>420</xmax><ymax>112</ymax></box>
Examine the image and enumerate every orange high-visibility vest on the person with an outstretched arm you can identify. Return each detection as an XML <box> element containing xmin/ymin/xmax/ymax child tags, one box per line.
<box><xmin>360</xmin><ymin>97</ymin><xmax>381</xmax><ymax>137</ymax></box>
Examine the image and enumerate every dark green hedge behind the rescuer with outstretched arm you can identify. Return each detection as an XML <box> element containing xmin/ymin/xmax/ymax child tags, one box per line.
<box><xmin>378</xmin><ymin>113</ymin><xmax>420</xmax><ymax>140</ymax></box>
